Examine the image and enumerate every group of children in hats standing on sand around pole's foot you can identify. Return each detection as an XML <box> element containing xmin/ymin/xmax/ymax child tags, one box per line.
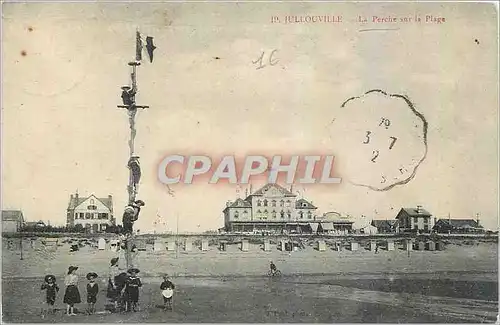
<box><xmin>41</xmin><ymin>258</ymin><xmax>175</xmax><ymax>317</ymax></box>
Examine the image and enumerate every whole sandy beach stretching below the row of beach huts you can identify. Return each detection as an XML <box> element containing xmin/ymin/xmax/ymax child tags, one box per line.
<box><xmin>2</xmin><ymin>238</ymin><xmax>498</xmax><ymax>323</ymax></box>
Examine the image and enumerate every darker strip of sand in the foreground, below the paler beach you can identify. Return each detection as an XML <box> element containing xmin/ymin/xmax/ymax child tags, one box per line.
<box><xmin>2</xmin><ymin>274</ymin><xmax>498</xmax><ymax>323</ymax></box>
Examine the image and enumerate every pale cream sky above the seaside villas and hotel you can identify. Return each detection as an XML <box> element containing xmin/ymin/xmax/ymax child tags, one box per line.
<box><xmin>1</xmin><ymin>3</ymin><xmax>498</xmax><ymax>232</ymax></box>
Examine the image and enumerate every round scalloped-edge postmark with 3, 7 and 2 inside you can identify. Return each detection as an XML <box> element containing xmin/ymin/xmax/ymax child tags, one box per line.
<box><xmin>330</xmin><ymin>89</ymin><xmax>428</xmax><ymax>191</ymax></box>
